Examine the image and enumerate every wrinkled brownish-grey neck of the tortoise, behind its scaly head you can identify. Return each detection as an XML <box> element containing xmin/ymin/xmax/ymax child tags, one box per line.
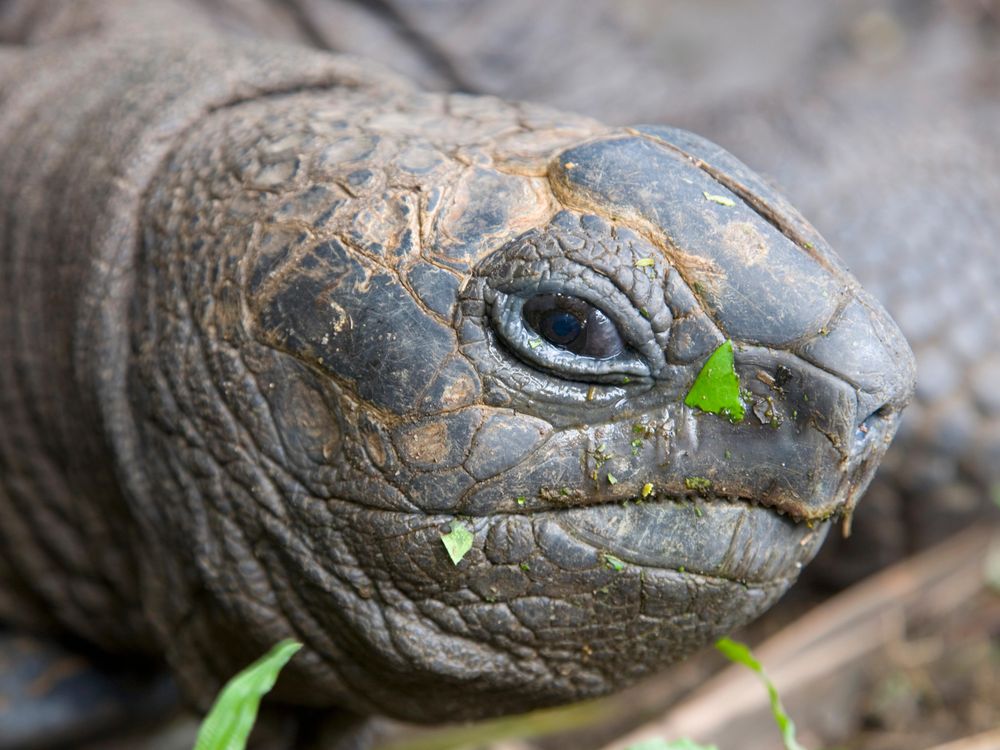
<box><xmin>0</xmin><ymin>19</ymin><xmax>394</xmax><ymax>647</ymax></box>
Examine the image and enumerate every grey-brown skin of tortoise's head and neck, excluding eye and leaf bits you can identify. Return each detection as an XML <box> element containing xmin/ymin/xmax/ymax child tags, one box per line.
<box><xmin>0</xmin><ymin>3</ymin><xmax>914</xmax><ymax>739</ymax></box>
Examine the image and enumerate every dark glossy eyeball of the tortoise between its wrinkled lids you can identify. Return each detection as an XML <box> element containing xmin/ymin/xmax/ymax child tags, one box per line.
<box><xmin>522</xmin><ymin>294</ymin><xmax>625</xmax><ymax>359</ymax></box>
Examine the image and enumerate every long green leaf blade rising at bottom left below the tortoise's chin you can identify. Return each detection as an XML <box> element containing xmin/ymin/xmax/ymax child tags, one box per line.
<box><xmin>194</xmin><ymin>640</ymin><xmax>302</xmax><ymax>750</ymax></box>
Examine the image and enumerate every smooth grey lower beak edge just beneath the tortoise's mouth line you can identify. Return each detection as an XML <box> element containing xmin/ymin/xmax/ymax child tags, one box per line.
<box><xmin>539</xmin><ymin>499</ymin><xmax>830</xmax><ymax>585</ymax></box>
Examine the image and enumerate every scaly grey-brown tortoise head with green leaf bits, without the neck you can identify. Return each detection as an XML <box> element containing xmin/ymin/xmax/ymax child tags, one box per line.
<box><xmin>130</xmin><ymin>91</ymin><xmax>913</xmax><ymax>720</ymax></box>
